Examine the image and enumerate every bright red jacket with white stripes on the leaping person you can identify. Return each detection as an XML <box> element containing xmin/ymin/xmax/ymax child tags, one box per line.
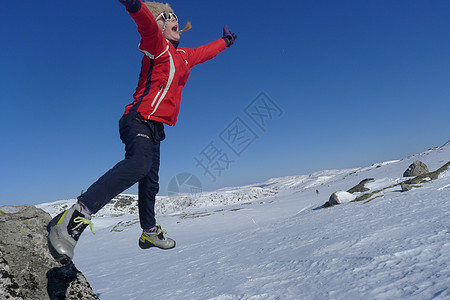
<box><xmin>125</xmin><ymin>4</ymin><xmax>226</xmax><ymax>126</ymax></box>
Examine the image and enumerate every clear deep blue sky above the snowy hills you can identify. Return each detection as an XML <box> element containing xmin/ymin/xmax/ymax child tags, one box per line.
<box><xmin>0</xmin><ymin>0</ymin><xmax>450</xmax><ymax>205</ymax></box>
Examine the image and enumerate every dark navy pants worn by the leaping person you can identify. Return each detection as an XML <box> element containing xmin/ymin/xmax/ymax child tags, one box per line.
<box><xmin>78</xmin><ymin>112</ymin><xmax>165</xmax><ymax>229</ymax></box>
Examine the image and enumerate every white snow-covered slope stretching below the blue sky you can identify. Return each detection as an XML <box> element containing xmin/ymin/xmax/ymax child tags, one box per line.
<box><xmin>39</xmin><ymin>143</ymin><xmax>450</xmax><ymax>300</ymax></box>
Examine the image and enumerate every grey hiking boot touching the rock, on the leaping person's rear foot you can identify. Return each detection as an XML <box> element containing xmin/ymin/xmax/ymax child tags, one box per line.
<box><xmin>47</xmin><ymin>203</ymin><xmax>94</xmax><ymax>265</ymax></box>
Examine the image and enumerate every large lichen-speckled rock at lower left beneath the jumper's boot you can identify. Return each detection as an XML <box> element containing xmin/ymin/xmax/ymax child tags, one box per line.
<box><xmin>0</xmin><ymin>205</ymin><xmax>98</xmax><ymax>300</ymax></box>
